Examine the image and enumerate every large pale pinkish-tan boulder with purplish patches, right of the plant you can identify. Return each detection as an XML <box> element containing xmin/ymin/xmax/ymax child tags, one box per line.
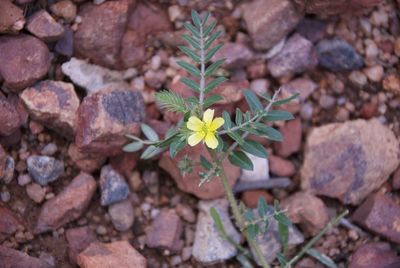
<box><xmin>301</xmin><ymin>120</ymin><xmax>399</xmax><ymax>205</ymax></box>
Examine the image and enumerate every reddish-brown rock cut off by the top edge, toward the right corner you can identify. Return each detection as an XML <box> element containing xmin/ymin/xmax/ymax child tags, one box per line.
<box><xmin>295</xmin><ymin>0</ymin><xmax>382</xmax><ymax>15</ymax></box>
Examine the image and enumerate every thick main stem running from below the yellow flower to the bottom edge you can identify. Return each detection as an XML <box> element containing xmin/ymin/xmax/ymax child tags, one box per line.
<box><xmin>209</xmin><ymin>150</ymin><xmax>270</xmax><ymax>268</ymax></box>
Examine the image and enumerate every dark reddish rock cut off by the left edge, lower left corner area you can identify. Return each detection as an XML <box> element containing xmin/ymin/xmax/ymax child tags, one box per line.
<box><xmin>0</xmin><ymin>203</ymin><xmax>23</xmax><ymax>243</ymax></box>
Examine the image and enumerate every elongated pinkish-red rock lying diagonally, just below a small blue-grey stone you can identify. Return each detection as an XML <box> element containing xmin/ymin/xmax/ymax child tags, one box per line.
<box><xmin>35</xmin><ymin>172</ymin><xmax>96</xmax><ymax>234</ymax></box>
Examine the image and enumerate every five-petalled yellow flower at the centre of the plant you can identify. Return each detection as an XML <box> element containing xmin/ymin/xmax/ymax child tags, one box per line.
<box><xmin>186</xmin><ymin>109</ymin><xmax>225</xmax><ymax>149</ymax></box>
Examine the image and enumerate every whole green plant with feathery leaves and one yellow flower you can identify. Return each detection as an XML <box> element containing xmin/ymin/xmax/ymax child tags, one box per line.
<box><xmin>124</xmin><ymin>11</ymin><xmax>348</xmax><ymax>267</ymax></box>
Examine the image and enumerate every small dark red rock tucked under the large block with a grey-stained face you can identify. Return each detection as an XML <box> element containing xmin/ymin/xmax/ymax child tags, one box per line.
<box><xmin>68</xmin><ymin>143</ymin><xmax>106</xmax><ymax>173</ymax></box>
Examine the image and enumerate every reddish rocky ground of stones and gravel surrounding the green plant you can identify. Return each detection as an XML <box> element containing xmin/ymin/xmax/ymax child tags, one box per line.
<box><xmin>0</xmin><ymin>0</ymin><xmax>400</xmax><ymax>268</ymax></box>
